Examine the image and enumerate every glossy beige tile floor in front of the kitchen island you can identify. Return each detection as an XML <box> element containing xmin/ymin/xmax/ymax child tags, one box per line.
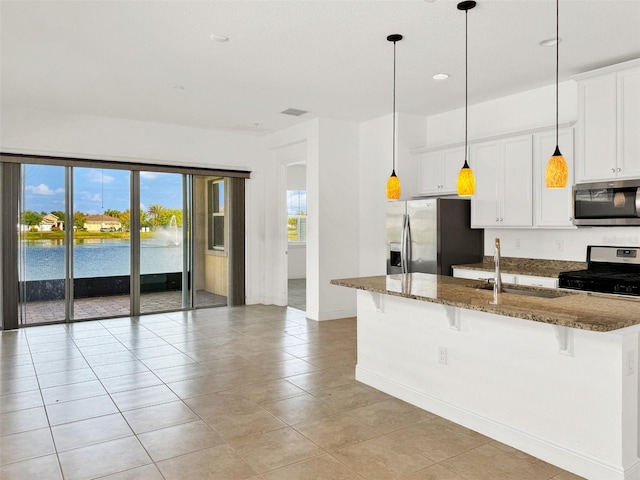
<box><xmin>0</xmin><ymin>306</ymin><xmax>578</xmax><ymax>480</ymax></box>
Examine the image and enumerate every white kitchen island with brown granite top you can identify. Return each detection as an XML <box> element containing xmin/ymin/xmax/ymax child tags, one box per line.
<box><xmin>331</xmin><ymin>274</ymin><xmax>640</xmax><ymax>480</ymax></box>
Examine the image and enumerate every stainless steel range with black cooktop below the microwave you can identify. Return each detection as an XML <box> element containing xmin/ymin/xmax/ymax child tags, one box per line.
<box><xmin>558</xmin><ymin>245</ymin><xmax>640</xmax><ymax>296</ymax></box>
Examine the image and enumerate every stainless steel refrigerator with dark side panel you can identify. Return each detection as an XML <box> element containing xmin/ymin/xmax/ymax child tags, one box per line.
<box><xmin>387</xmin><ymin>198</ymin><xmax>484</xmax><ymax>275</ymax></box>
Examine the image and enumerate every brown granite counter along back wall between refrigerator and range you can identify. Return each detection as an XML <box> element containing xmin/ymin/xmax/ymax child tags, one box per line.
<box><xmin>453</xmin><ymin>256</ymin><xmax>587</xmax><ymax>278</ymax></box>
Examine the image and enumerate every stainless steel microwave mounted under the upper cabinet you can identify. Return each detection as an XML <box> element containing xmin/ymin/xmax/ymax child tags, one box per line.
<box><xmin>573</xmin><ymin>179</ymin><xmax>640</xmax><ymax>226</ymax></box>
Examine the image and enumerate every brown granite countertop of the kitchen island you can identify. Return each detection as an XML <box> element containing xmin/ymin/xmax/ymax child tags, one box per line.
<box><xmin>331</xmin><ymin>273</ymin><xmax>640</xmax><ymax>332</ymax></box>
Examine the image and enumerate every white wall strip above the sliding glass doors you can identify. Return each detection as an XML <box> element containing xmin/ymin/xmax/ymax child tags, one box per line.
<box><xmin>0</xmin><ymin>105</ymin><xmax>262</xmax><ymax>170</ymax></box>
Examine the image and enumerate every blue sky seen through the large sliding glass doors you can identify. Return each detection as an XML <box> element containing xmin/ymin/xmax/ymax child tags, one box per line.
<box><xmin>23</xmin><ymin>165</ymin><xmax>182</xmax><ymax>215</ymax></box>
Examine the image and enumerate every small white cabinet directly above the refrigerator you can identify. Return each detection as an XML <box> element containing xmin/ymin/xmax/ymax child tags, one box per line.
<box><xmin>418</xmin><ymin>147</ymin><xmax>464</xmax><ymax>195</ymax></box>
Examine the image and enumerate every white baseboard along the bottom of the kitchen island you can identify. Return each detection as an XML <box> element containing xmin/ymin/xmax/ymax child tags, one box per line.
<box><xmin>356</xmin><ymin>366</ymin><xmax>640</xmax><ymax>480</ymax></box>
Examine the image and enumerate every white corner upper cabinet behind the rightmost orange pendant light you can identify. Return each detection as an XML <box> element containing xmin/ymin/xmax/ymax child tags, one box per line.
<box><xmin>533</xmin><ymin>128</ymin><xmax>576</xmax><ymax>228</ymax></box>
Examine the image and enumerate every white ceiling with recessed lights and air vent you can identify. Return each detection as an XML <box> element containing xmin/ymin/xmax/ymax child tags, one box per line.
<box><xmin>0</xmin><ymin>0</ymin><xmax>640</xmax><ymax>133</ymax></box>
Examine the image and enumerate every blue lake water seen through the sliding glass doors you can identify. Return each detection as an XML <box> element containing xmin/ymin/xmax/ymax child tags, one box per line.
<box><xmin>20</xmin><ymin>239</ymin><xmax>182</xmax><ymax>280</ymax></box>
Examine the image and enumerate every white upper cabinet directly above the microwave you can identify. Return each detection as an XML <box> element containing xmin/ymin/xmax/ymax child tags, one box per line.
<box><xmin>576</xmin><ymin>60</ymin><xmax>640</xmax><ymax>183</ymax></box>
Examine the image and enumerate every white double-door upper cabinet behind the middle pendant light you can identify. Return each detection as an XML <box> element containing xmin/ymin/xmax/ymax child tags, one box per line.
<box><xmin>469</xmin><ymin>134</ymin><xmax>533</xmax><ymax>228</ymax></box>
